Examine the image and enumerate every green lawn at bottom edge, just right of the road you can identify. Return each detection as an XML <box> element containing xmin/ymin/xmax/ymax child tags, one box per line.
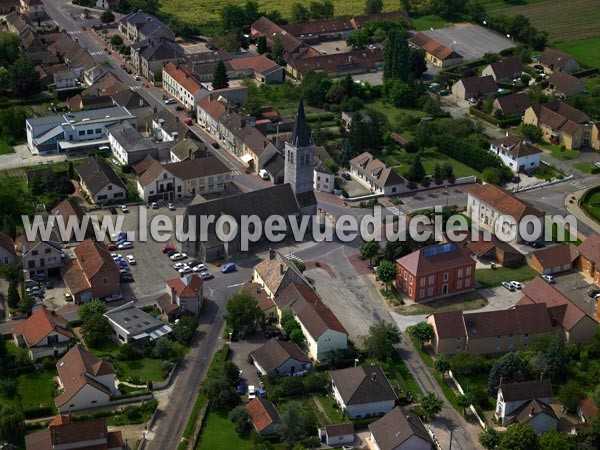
<box><xmin>196</xmin><ymin>412</ymin><xmax>252</xmax><ymax>450</ymax></box>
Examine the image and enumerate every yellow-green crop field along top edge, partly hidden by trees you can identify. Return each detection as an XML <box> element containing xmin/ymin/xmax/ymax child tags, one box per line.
<box><xmin>160</xmin><ymin>0</ymin><xmax>399</xmax><ymax>27</ymax></box>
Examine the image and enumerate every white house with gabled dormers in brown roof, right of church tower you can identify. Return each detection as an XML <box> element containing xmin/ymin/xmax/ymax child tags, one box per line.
<box><xmin>350</xmin><ymin>152</ymin><xmax>408</xmax><ymax>195</ymax></box>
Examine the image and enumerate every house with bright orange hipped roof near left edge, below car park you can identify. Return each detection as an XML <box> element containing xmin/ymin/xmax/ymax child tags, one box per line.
<box><xmin>12</xmin><ymin>307</ymin><xmax>74</xmax><ymax>361</ymax></box>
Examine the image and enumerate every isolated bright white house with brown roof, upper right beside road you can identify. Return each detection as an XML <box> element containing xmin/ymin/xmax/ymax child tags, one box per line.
<box><xmin>490</xmin><ymin>133</ymin><xmax>542</xmax><ymax>173</ymax></box>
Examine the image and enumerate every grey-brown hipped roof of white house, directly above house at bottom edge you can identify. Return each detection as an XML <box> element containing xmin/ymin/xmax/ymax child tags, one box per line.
<box><xmin>329</xmin><ymin>366</ymin><xmax>397</xmax><ymax>406</ymax></box>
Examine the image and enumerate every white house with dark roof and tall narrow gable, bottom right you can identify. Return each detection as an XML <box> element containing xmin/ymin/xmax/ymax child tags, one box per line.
<box><xmin>494</xmin><ymin>380</ymin><xmax>553</xmax><ymax>426</ymax></box>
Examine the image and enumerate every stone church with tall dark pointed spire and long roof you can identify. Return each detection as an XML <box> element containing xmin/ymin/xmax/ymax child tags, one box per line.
<box><xmin>182</xmin><ymin>100</ymin><xmax>317</xmax><ymax>261</ymax></box>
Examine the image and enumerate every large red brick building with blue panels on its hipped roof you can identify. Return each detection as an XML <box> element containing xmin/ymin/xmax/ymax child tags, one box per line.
<box><xmin>395</xmin><ymin>242</ymin><xmax>475</xmax><ymax>302</ymax></box>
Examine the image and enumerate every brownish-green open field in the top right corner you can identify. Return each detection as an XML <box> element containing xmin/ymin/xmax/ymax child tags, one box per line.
<box><xmin>490</xmin><ymin>0</ymin><xmax>600</xmax><ymax>41</ymax></box>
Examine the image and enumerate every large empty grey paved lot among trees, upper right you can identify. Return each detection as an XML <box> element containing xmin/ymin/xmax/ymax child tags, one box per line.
<box><xmin>423</xmin><ymin>24</ymin><xmax>515</xmax><ymax>60</ymax></box>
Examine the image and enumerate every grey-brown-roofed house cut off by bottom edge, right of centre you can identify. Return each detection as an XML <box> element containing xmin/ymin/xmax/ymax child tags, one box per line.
<box><xmin>369</xmin><ymin>407</ymin><xmax>436</xmax><ymax>450</ymax></box>
